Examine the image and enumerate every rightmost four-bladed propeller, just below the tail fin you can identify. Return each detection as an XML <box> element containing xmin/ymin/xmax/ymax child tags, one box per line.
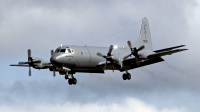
<box><xmin>124</xmin><ymin>41</ymin><xmax>145</xmax><ymax>66</ymax></box>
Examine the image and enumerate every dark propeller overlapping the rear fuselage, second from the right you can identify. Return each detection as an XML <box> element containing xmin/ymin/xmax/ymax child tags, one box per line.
<box><xmin>97</xmin><ymin>45</ymin><xmax>118</xmax><ymax>72</ymax></box>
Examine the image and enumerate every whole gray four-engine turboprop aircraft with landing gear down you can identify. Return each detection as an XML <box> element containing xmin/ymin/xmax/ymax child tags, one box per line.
<box><xmin>11</xmin><ymin>18</ymin><xmax>187</xmax><ymax>85</ymax></box>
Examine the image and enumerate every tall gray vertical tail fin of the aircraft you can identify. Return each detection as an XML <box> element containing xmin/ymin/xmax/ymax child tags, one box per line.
<box><xmin>134</xmin><ymin>17</ymin><xmax>153</xmax><ymax>51</ymax></box>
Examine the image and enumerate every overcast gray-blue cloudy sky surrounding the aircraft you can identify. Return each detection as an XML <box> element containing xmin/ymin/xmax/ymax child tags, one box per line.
<box><xmin>0</xmin><ymin>0</ymin><xmax>200</xmax><ymax>112</ymax></box>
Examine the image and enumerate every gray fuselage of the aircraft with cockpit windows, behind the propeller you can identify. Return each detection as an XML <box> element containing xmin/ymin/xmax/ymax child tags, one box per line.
<box><xmin>50</xmin><ymin>45</ymin><xmax>130</xmax><ymax>73</ymax></box>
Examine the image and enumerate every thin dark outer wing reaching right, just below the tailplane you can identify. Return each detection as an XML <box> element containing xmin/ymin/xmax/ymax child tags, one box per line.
<box><xmin>148</xmin><ymin>49</ymin><xmax>188</xmax><ymax>58</ymax></box>
